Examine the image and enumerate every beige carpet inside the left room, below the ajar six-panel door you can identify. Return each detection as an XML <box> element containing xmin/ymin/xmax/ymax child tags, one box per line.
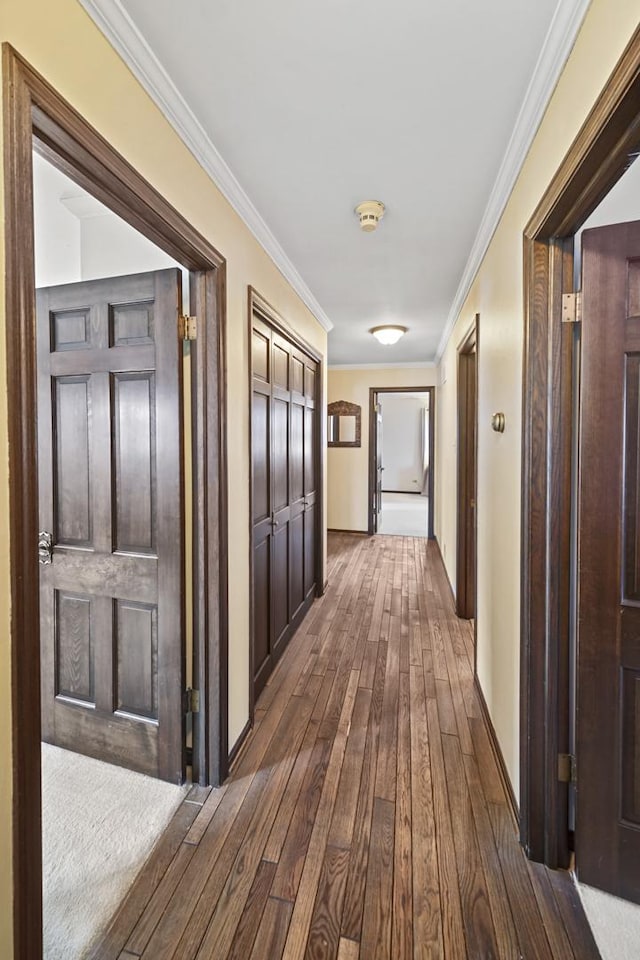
<box><xmin>42</xmin><ymin>744</ymin><xmax>188</xmax><ymax>960</ymax></box>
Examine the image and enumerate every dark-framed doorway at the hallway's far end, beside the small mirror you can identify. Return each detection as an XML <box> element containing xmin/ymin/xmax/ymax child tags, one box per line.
<box><xmin>368</xmin><ymin>387</ymin><xmax>435</xmax><ymax>539</ymax></box>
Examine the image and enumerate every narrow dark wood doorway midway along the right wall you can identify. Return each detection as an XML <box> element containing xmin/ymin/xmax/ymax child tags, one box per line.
<box><xmin>456</xmin><ymin>338</ymin><xmax>478</xmax><ymax>620</ymax></box>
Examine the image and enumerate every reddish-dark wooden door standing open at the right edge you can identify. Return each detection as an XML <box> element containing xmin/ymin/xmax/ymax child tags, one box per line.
<box><xmin>576</xmin><ymin>223</ymin><xmax>640</xmax><ymax>903</ymax></box>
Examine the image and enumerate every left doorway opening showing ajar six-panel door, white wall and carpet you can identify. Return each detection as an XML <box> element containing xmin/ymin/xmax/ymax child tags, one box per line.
<box><xmin>33</xmin><ymin>152</ymin><xmax>197</xmax><ymax>958</ymax></box>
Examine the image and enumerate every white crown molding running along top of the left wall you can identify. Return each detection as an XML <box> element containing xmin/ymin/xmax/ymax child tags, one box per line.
<box><xmin>80</xmin><ymin>0</ymin><xmax>333</xmax><ymax>332</ymax></box>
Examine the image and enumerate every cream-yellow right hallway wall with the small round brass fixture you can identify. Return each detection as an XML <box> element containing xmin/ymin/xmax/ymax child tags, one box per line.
<box><xmin>436</xmin><ymin>0</ymin><xmax>640</xmax><ymax>804</ymax></box>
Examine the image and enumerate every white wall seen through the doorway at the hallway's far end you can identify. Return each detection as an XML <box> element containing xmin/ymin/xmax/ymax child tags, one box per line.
<box><xmin>379</xmin><ymin>393</ymin><xmax>428</xmax><ymax>493</ymax></box>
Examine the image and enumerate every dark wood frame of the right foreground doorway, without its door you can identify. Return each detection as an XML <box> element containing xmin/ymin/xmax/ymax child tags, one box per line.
<box><xmin>520</xmin><ymin>29</ymin><xmax>640</xmax><ymax>867</ymax></box>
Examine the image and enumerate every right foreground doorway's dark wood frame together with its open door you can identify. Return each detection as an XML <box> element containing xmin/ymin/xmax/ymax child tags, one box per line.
<box><xmin>521</xmin><ymin>18</ymin><xmax>640</xmax><ymax>920</ymax></box>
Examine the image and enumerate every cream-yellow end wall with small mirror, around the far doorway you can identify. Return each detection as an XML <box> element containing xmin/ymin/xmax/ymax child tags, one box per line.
<box><xmin>327</xmin><ymin>367</ymin><xmax>438</xmax><ymax>531</ymax></box>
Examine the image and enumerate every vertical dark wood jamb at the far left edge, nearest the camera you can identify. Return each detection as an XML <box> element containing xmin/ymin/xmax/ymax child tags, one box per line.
<box><xmin>3</xmin><ymin>46</ymin><xmax>42</xmax><ymax>960</ymax></box>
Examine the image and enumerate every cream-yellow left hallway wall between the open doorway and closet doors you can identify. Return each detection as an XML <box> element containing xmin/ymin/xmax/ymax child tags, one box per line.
<box><xmin>0</xmin><ymin>0</ymin><xmax>326</xmax><ymax>944</ymax></box>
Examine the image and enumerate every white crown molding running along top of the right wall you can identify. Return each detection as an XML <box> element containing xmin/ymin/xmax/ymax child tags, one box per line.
<box><xmin>436</xmin><ymin>0</ymin><xmax>591</xmax><ymax>361</ymax></box>
